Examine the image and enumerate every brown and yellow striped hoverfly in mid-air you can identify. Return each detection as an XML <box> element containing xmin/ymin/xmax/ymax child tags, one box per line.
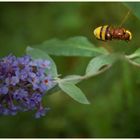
<box><xmin>93</xmin><ymin>11</ymin><xmax>132</xmax><ymax>41</ymax></box>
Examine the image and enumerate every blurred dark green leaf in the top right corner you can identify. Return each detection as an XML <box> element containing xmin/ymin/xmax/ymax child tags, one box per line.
<box><xmin>124</xmin><ymin>2</ymin><xmax>140</xmax><ymax>18</ymax></box>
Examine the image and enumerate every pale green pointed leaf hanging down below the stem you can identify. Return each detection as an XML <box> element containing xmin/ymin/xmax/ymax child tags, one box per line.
<box><xmin>59</xmin><ymin>82</ymin><xmax>89</xmax><ymax>104</ymax></box>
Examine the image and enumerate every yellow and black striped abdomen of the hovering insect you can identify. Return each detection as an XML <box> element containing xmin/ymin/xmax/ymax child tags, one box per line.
<box><xmin>94</xmin><ymin>25</ymin><xmax>109</xmax><ymax>41</ymax></box>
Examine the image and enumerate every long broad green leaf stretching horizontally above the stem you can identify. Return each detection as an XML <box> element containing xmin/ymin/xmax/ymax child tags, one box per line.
<box><xmin>33</xmin><ymin>36</ymin><xmax>108</xmax><ymax>57</ymax></box>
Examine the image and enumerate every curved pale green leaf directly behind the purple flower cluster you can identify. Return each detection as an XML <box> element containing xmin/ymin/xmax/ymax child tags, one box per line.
<box><xmin>26</xmin><ymin>47</ymin><xmax>57</xmax><ymax>77</ymax></box>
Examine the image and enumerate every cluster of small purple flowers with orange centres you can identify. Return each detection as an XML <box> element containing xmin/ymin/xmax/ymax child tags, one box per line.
<box><xmin>0</xmin><ymin>55</ymin><xmax>54</xmax><ymax>118</ymax></box>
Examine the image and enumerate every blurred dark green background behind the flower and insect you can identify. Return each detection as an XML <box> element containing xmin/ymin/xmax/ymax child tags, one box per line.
<box><xmin>0</xmin><ymin>2</ymin><xmax>140</xmax><ymax>138</ymax></box>
